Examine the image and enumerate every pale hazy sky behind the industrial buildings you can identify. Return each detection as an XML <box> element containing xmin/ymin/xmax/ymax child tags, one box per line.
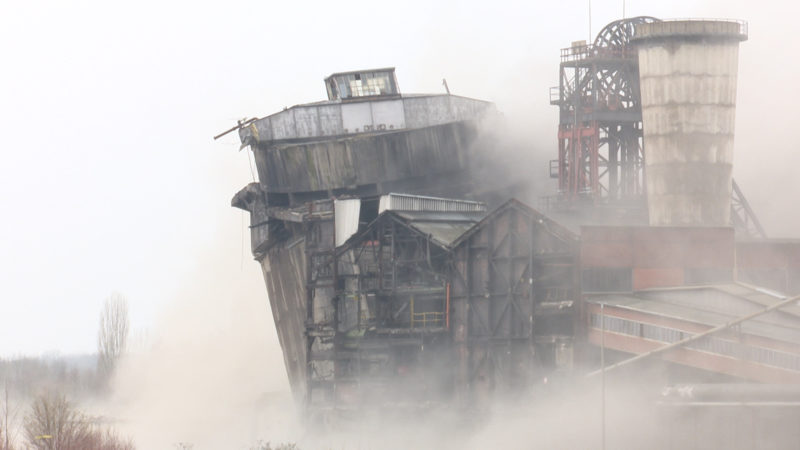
<box><xmin>0</xmin><ymin>0</ymin><xmax>800</xmax><ymax>356</ymax></box>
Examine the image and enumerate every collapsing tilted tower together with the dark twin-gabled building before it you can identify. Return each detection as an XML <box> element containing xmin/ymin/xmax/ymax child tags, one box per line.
<box><xmin>228</xmin><ymin>65</ymin><xmax>577</xmax><ymax>410</ymax></box>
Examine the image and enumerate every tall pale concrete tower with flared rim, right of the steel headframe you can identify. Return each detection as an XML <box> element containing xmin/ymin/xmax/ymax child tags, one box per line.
<box><xmin>633</xmin><ymin>20</ymin><xmax>747</xmax><ymax>226</ymax></box>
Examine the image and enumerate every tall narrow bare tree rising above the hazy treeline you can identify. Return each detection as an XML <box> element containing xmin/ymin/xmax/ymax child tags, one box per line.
<box><xmin>97</xmin><ymin>293</ymin><xmax>128</xmax><ymax>381</ymax></box>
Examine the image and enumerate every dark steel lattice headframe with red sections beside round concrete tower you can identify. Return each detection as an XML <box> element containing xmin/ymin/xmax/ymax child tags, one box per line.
<box><xmin>550</xmin><ymin>17</ymin><xmax>658</xmax><ymax>202</ymax></box>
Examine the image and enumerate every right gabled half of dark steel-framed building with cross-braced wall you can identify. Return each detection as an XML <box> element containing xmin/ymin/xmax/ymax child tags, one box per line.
<box><xmin>451</xmin><ymin>201</ymin><xmax>578</xmax><ymax>404</ymax></box>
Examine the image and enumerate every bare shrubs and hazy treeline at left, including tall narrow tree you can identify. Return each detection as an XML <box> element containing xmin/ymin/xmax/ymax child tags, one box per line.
<box><xmin>0</xmin><ymin>294</ymin><xmax>134</xmax><ymax>450</ymax></box>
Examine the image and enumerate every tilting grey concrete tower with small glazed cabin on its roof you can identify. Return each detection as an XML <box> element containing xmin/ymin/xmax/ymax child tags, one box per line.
<box><xmin>232</xmin><ymin>68</ymin><xmax>536</xmax><ymax>406</ymax></box>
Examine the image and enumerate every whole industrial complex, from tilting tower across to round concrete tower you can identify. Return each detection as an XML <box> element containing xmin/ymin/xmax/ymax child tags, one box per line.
<box><xmin>225</xmin><ymin>17</ymin><xmax>800</xmax><ymax>446</ymax></box>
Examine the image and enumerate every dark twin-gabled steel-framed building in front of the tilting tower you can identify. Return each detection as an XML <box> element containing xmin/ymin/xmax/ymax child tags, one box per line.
<box><xmin>296</xmin><ymin>201</ymin><xmax>579</xmax><ymax>416</ymax></box>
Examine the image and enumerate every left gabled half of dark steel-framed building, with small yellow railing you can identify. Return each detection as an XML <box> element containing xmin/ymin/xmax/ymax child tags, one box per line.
<box><xmin>306</xmin><ymin>214</ymin><xmax>460</xmax><ymax>409</ymax></box>
